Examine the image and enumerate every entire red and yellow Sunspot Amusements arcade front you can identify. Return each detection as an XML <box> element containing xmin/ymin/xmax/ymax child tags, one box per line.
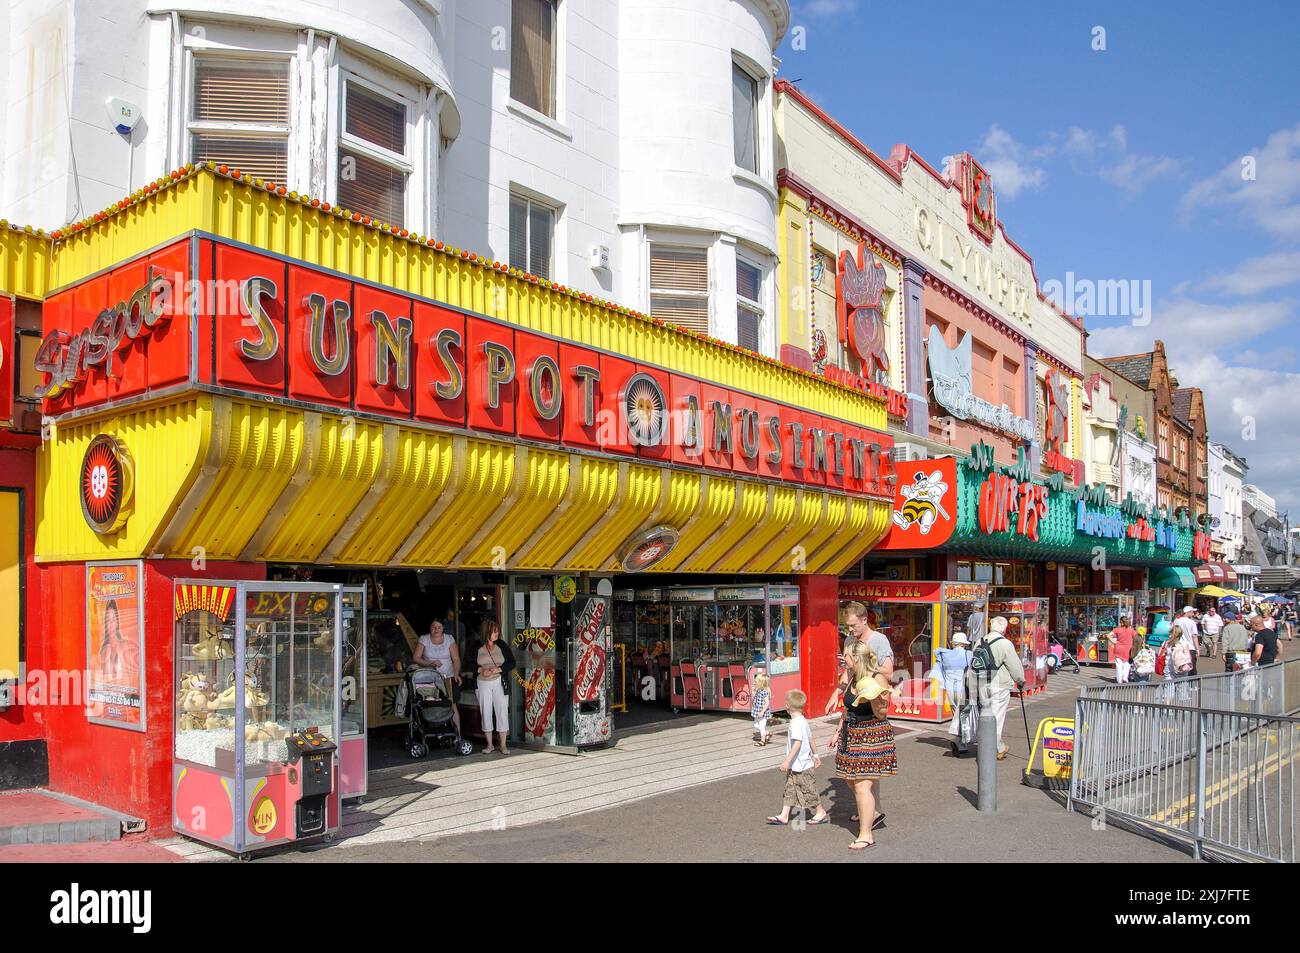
<box><xmin>15</xmin><ymin>163</ymin><xmax>894</xmax><ymax>850</ymax></box>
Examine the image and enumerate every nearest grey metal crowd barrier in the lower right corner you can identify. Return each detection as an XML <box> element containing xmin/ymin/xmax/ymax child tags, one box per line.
<box><xmin>1070</xmin><ymin>659</ymin><xmax>1300</xmax><ymax>863</ymax></box>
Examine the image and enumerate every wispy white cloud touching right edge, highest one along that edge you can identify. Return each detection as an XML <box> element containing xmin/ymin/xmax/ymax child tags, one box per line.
<box><xmin>1183</xmin><ymin>126</ymin><xmax>1300</xmax><ymax>238</ymax></box>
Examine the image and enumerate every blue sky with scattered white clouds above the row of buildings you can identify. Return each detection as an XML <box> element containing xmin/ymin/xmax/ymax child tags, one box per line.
<box><xmin>777</xmin><ymin>0</ymin><xmax>1300</xmax><ymax>523</ymax></box>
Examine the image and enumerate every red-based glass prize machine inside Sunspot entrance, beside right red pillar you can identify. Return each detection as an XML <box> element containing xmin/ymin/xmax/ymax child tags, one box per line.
<box><xmin>666</xmin><ymin>585</ymin><xmax>800</xmax><ymax>712</ymax></box>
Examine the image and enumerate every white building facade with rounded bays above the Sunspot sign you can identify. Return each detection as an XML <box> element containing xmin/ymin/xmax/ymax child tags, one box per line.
<box><xmin>0</xmin><ymin>0</ymin><xmax>790</xmax><ymax>356</ymax></box>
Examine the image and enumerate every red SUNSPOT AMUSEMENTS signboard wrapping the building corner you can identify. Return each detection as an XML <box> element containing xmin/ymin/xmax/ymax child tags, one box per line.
<box><xmin>38</xmin><ymin>239</ymin><xmax>894</xmax><ymax>497</ymax></box>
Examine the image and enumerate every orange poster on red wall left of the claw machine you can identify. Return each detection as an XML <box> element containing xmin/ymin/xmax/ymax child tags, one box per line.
<box><xmin>86</xmin><ymin>560</ymin><xmax>146</xmax><ymax>731</ymax></box>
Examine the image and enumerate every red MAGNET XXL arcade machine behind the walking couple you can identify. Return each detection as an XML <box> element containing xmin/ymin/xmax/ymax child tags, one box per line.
<box><xmin>840</xmin><ymin>580</ymin><xmax>988</xmax><ymax>722</ymax></box>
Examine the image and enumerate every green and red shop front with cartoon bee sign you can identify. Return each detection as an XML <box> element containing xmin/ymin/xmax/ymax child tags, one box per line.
<box><xmin>841</xmin><ymin>445</ymin><xmax>1208</xmax><ymax>696</ymax></box>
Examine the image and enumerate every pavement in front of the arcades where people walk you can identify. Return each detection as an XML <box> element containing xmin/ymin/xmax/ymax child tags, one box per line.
<box><xmin>17</xmin><ymin>668</ymin><xmax>1191</xmax><ymax>863</ymax></box>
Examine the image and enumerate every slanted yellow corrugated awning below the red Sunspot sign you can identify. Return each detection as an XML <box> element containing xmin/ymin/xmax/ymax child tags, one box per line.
<box><xmin>36</xmin><ymin>394</ymin><xmax>889</xmax><ymax>575</ymax></box>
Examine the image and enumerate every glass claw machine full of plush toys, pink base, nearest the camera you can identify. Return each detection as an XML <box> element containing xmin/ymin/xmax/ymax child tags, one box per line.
<box><xmin>172</xmin><ymin>580</ymin><xmax>345</xmax><ymax>857</ymax></box>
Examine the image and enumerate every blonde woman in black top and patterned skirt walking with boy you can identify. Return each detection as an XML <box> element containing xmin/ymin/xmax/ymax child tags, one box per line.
<box><xmin>835</xmin><ymin>641</ymin><xmax>898</xmax><ymax>850</ymax></box>
